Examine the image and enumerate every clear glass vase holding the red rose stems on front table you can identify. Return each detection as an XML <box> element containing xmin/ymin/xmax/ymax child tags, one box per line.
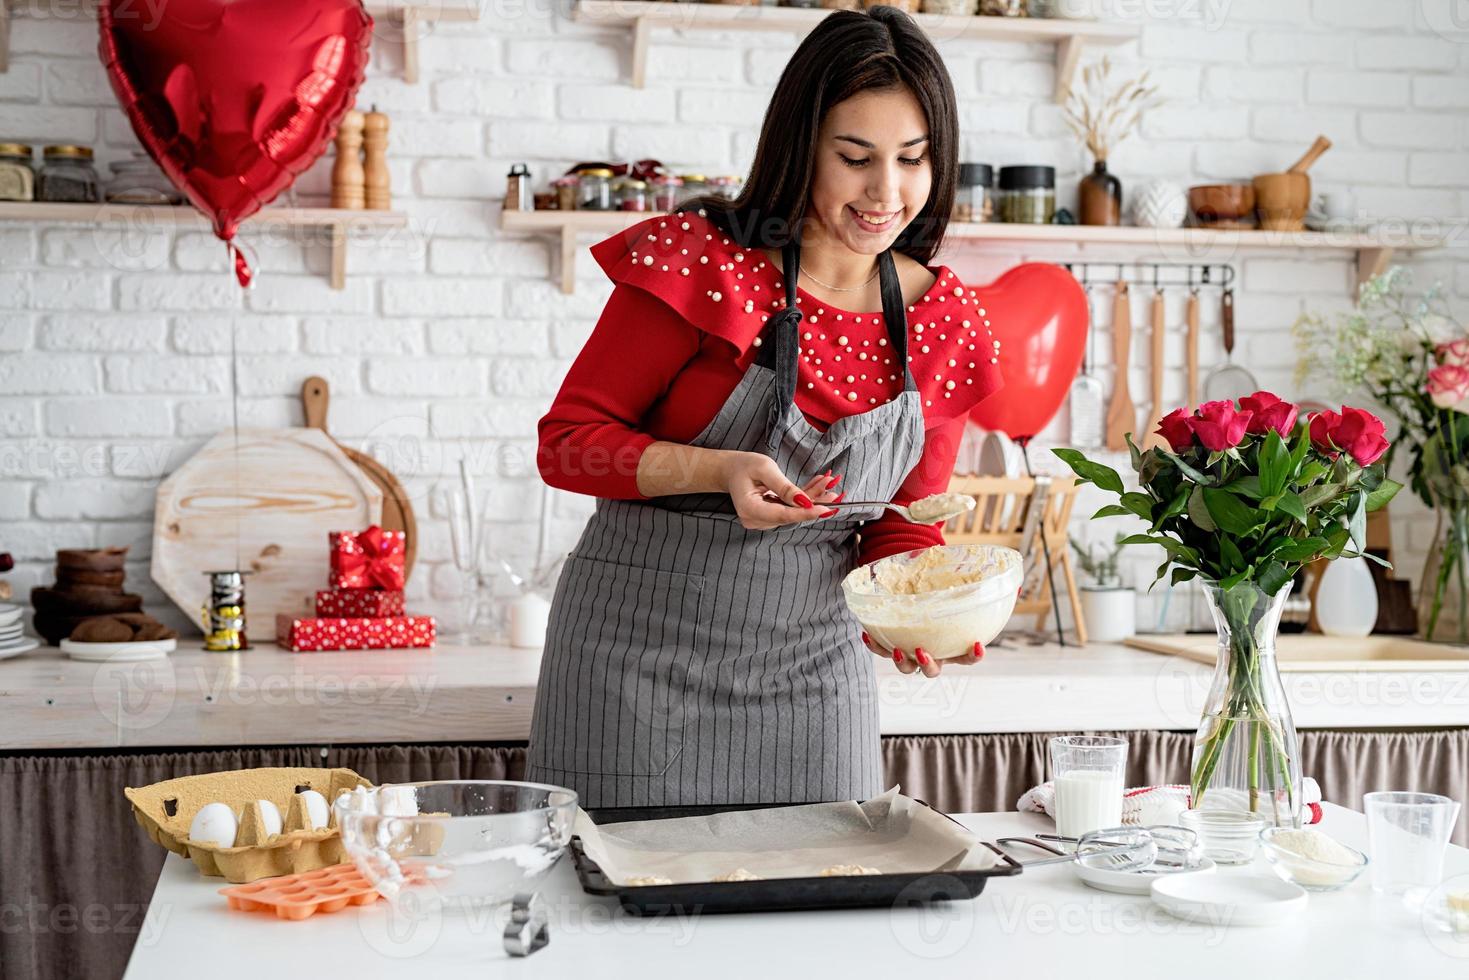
<box><xmin>1188</xmin><ymin>582</ymin><xmax>1302</xmax><ymax>827</ymax></box>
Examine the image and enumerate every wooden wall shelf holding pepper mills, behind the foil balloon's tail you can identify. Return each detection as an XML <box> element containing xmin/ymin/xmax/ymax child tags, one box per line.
<box><xmin>0</xmin><ymin>201</ymin><xmax>408</xmax><ymax>289</ymax></box>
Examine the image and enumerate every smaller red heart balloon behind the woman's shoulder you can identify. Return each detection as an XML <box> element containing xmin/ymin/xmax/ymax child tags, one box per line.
<box><xmin>970</xmin><ymin>262</ymin><xmax>1091</xmax><ymax>441</ymax></box>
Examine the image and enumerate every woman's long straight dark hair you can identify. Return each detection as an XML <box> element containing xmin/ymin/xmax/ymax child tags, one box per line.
<box><xmin>680</xmin><ymin>7</ymin><xmax>959</xmax><ymax>264</ymax></box>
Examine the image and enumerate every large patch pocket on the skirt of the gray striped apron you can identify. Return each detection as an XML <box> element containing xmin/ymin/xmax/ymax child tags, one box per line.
<box><xmin>538</xmin><ymin>554</ymin><xmax>708</xmax><ymax>776</ymax></box>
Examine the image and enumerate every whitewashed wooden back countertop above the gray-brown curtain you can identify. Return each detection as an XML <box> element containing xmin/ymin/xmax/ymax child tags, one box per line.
<box><xmin>0</xmin><ymin>636</ymin><xmax>1469</xmax><ymax>749</ymax></box>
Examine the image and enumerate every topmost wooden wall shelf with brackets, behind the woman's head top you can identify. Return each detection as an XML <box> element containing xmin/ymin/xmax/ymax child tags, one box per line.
<box><xmin>571</xmin><ymin>0</ymin><xmax>1141</xmax><ymax>103</ymax></box>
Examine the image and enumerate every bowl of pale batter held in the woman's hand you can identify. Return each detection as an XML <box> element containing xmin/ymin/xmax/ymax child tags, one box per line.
<box><xmin>842</xmin><ymin>545</ymin><xmax>1021</xmax><ymax>660</ymax></box>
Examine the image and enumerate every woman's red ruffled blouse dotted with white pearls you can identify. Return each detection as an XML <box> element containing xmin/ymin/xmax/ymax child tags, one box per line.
<box><xmin>538</xmin><ymin>212</ymin><xmax>1000</xmax><ymax>563</ymax></box>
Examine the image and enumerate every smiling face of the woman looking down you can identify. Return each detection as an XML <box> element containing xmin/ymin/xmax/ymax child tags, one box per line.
<box><xmin>809</xmin><ymin>88</ymin><xmax>933</xmax><ymax>256</ymax></box>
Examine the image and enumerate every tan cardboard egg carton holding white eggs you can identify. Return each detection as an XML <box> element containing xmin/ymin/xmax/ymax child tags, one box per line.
<box><xmin>122</xmin><ymin>768</ymin><xmax>372</xmax><ymax>884</ymax></box>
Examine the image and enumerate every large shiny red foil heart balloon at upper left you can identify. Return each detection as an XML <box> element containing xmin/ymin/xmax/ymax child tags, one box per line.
<box><xmin>98</xmin><ymin>0</ymin><xmax>372</xmax><ymax>241</ymax></box>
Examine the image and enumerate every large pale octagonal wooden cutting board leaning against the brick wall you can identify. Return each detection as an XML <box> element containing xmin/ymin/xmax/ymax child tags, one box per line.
<box><xmin>151</xmin><ymin>429</ymin><xmax>382</xmax><ymax>642</ymax></box>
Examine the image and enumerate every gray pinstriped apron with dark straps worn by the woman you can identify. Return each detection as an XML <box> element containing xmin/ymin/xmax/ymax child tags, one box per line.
<box><xmin>527</xmin><ymin>245</ymin><xmax>924</xmax><ymax>807</ymax></box>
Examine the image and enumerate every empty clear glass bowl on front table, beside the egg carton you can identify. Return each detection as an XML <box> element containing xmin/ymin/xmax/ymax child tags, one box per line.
<box><xmin>332</xmin><ymin>780</ymin><xmax>576</xmax><ymax>912</ymax></box>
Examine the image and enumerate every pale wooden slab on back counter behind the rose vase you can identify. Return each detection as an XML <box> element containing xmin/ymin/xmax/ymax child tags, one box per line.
<box><xmin>1125</xmin><ymin>633</ymin><xmax>1469</xmax><ymax>671</ymax></box>
